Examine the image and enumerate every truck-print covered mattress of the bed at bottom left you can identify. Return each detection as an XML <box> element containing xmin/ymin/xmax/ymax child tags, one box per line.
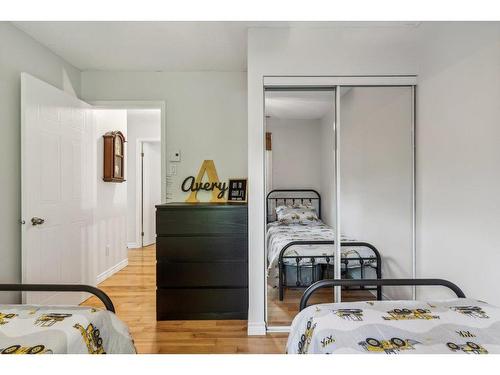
<box><xmin>0</xmin><ymin>305</ymin><xmax>136</xmax><ymax>354</ymax></box>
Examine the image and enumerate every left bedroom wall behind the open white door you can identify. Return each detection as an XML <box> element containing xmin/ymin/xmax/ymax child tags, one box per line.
<box><xmin>0</xmin><ymin>22</ymin><xmax>80</xmax><ymax>302</ymax></box>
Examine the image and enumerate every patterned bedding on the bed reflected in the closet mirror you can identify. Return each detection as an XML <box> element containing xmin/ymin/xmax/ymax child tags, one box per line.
<box><xmin>266</xmin><ymin>221</ymin><xmax>376</xmax><ymax>284</ymax></box>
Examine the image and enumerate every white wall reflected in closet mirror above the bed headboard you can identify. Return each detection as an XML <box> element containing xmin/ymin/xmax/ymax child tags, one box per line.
<box><xmin>266</xmin><ymin>118</ymin><xmax>321</xmax><ymax>194</ymax></box>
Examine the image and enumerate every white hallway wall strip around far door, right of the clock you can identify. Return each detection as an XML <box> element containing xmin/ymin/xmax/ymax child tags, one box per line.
<box><xmin>127</xmin><ymin>109</ymin><xmax>161</xmax><ymax>247</ymax></box>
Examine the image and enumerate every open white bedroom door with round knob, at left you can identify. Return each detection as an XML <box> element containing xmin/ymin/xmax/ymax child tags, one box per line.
<box><xmin>21</xmin><ymin>73</ymin><xmax>94</xmax><ymax>304</ymax></box>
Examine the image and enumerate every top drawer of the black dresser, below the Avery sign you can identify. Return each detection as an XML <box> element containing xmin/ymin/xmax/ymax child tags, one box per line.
<box><xmin>156</xmin><ymin>206</ymin><xmax>248</xmax><ymax>236</ymax></box>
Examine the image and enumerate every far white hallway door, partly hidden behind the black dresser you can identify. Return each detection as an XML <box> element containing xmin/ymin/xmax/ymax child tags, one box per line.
<box><xmin>142</xmin><ymin>142</ymin><xmax>161</xmax><ymax>246</ymax></box>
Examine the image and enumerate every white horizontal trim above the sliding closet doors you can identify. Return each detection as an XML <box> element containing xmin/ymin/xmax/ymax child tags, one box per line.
<box><xmin>264</xmin><ymin>75</ymin><xmax>417</xmax><ymax>87</ymax></box>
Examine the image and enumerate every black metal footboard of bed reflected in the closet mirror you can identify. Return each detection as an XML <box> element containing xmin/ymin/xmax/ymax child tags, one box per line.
<box><xmin>278</xmin><ymin>240</ymin><xmax>382</xmax><ymax>301</ymax></box>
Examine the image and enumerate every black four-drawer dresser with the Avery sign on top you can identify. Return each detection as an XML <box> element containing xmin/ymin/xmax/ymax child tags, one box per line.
<box><xmin>156</xmin><ymin>203</ymin><xmax>248</xmax><ymax>320</ymax></box>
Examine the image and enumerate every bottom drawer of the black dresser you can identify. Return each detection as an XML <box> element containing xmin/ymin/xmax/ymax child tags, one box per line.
<box><xmin>156</xmin><ymin>288</ymin><xmax>248</xmax><ymax>320</ymax></box>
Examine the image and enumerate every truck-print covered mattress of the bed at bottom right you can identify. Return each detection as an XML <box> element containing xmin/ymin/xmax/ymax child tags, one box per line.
<box><xmin>287</xmin><ymin>298</ymin><xmax>500</xmax><ymax>354</ymax></box>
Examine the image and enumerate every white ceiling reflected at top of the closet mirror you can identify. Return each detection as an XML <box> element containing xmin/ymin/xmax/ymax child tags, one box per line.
<box><xmin>265</xmin><ymin>91</ymin><xmax>334</xmax><ymax>120</ymax></box>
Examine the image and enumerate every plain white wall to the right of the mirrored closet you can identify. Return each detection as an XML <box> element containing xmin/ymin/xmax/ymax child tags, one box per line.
<box><xmin>417</xmin><ymin>22</ymin><xmax>500</xmax><ymax>305</ymax></box>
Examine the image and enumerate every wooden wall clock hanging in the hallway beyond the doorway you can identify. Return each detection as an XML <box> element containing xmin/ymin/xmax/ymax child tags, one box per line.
<box><xmin>103</xmin><ymin>131</ymin><xmax>125</xmax><ymax>182</ymax></box>
